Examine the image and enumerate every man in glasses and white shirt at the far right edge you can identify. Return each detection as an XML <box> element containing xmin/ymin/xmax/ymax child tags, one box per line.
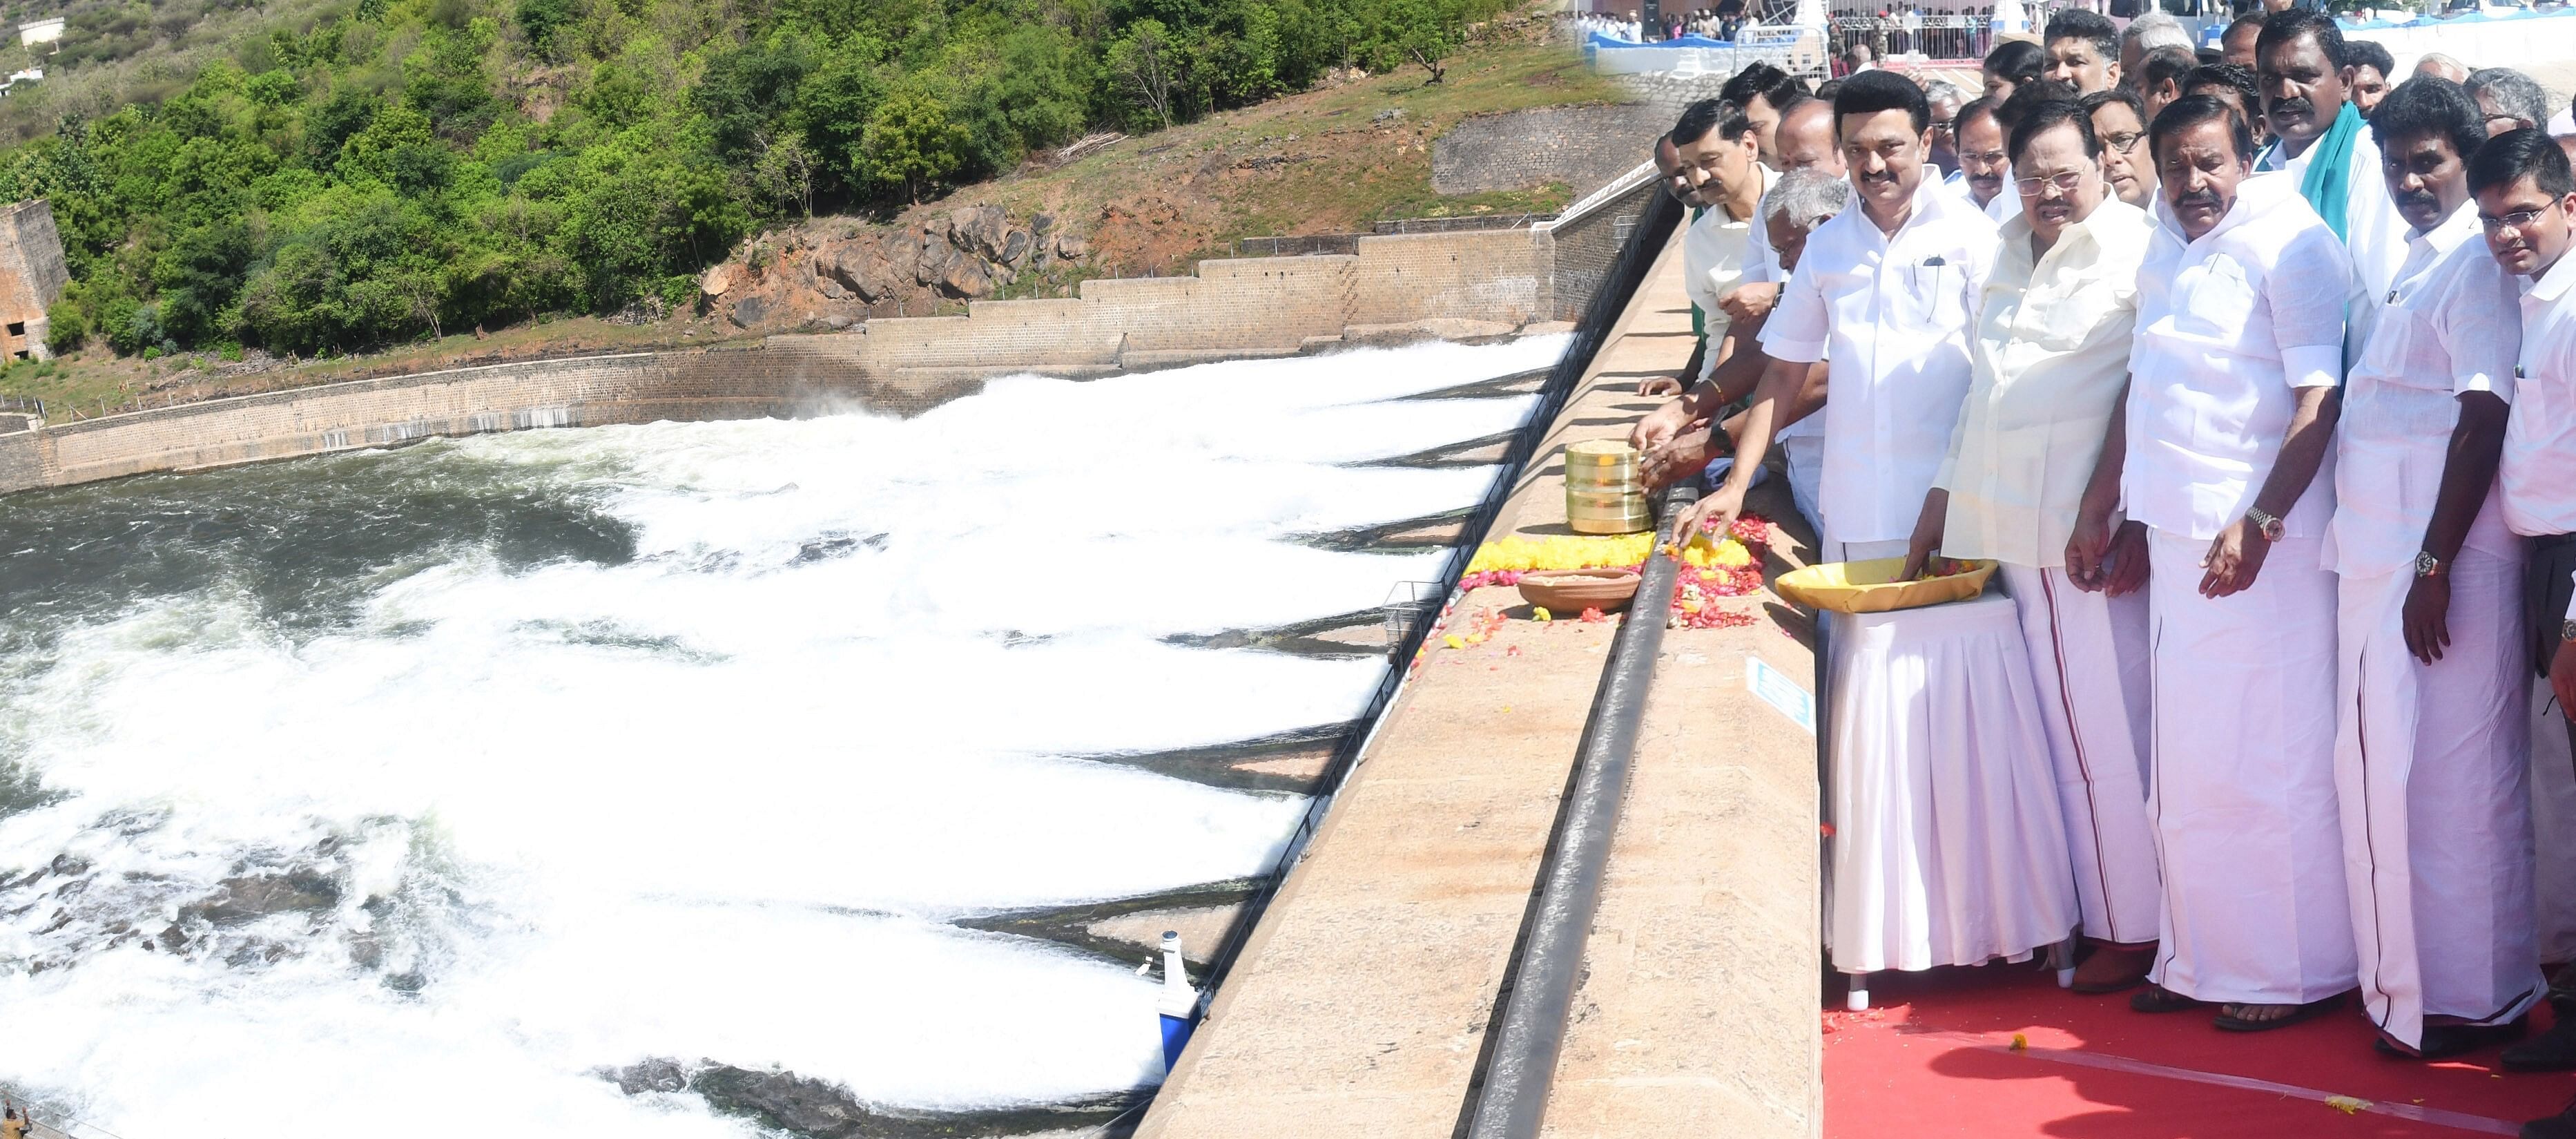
<box><xmin>2468</xmin><ymin>131</ymin><xmax>2576</xmax><ymax>1102</ymax></box>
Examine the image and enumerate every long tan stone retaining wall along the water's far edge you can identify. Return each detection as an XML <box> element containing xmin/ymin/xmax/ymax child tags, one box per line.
<box><xmin>0</xmin><ymin>229</ymin><xmax>1566</xmax><ymax>492</ymax></box>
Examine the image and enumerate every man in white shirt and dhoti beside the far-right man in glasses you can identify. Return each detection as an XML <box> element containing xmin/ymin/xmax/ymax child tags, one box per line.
<box><xmin>2329</xmin><ymin>77</ymin><xmax>2548</xmax><ymax>1059</ymax></box>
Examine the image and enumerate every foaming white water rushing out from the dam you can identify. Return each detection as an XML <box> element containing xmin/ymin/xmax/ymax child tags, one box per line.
<box><xmin>0</xmin><ymin>338</ymin><xmax>1564</xmax><ymax>1139</ymax></box>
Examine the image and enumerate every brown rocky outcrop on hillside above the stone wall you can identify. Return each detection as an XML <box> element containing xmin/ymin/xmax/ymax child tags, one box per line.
<box><xmin>698</xmin><ymin>206</ymin><xmax>1090</xmax><ymax>332</ymax></box>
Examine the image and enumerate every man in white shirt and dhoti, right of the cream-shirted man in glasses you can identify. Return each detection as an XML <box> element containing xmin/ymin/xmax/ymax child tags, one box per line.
<box><xmin>2079</xmin><ymin>95</ymin><xmax>2354</xmax><ymax>1031</ymax></box>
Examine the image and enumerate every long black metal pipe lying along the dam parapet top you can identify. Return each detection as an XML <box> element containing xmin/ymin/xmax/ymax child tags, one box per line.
<box><xmin>1469</xmin><ymin>487</ymin><xmax>1698</xmax><ymax>1139</ymax></box>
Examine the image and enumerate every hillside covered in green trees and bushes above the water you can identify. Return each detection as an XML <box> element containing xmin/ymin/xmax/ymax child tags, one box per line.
<box><xmin>0</xmin><ymin>0</ymin><xmax>1504</xmax><ymax>356</ymax></box>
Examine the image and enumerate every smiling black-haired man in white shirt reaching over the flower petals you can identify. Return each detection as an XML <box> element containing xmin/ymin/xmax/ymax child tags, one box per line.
<box><xmin>1698</xmin><ymin>72</ymin><xmax>1994</xmax><ymax>562</ymax></box>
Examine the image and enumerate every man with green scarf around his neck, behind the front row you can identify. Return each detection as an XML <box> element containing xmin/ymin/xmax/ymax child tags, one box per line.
<box><xmin>2254</xmin><ymin>8</ymin><xmax>2406</xmax><ymax>302</ymax></box>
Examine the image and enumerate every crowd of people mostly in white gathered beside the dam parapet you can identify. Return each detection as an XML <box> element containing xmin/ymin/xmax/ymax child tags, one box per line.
<box><xmin>1631</xmin><ymin>8</ymin><xmax>2576</xmax><ymax>1139</ymax></box>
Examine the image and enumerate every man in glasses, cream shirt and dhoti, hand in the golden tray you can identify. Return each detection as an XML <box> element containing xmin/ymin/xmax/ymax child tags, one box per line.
<box><xmin>1901</xmin><ymin>95</ymin><xmax>2159</xmax><ymax>992</ymax></box>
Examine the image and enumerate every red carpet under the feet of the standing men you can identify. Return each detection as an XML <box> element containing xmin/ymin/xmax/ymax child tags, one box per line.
<box><xmin>1824</xmin><ymin>964</ymin><xmax>2576</xmax><ymax>1139</ymax></box>
